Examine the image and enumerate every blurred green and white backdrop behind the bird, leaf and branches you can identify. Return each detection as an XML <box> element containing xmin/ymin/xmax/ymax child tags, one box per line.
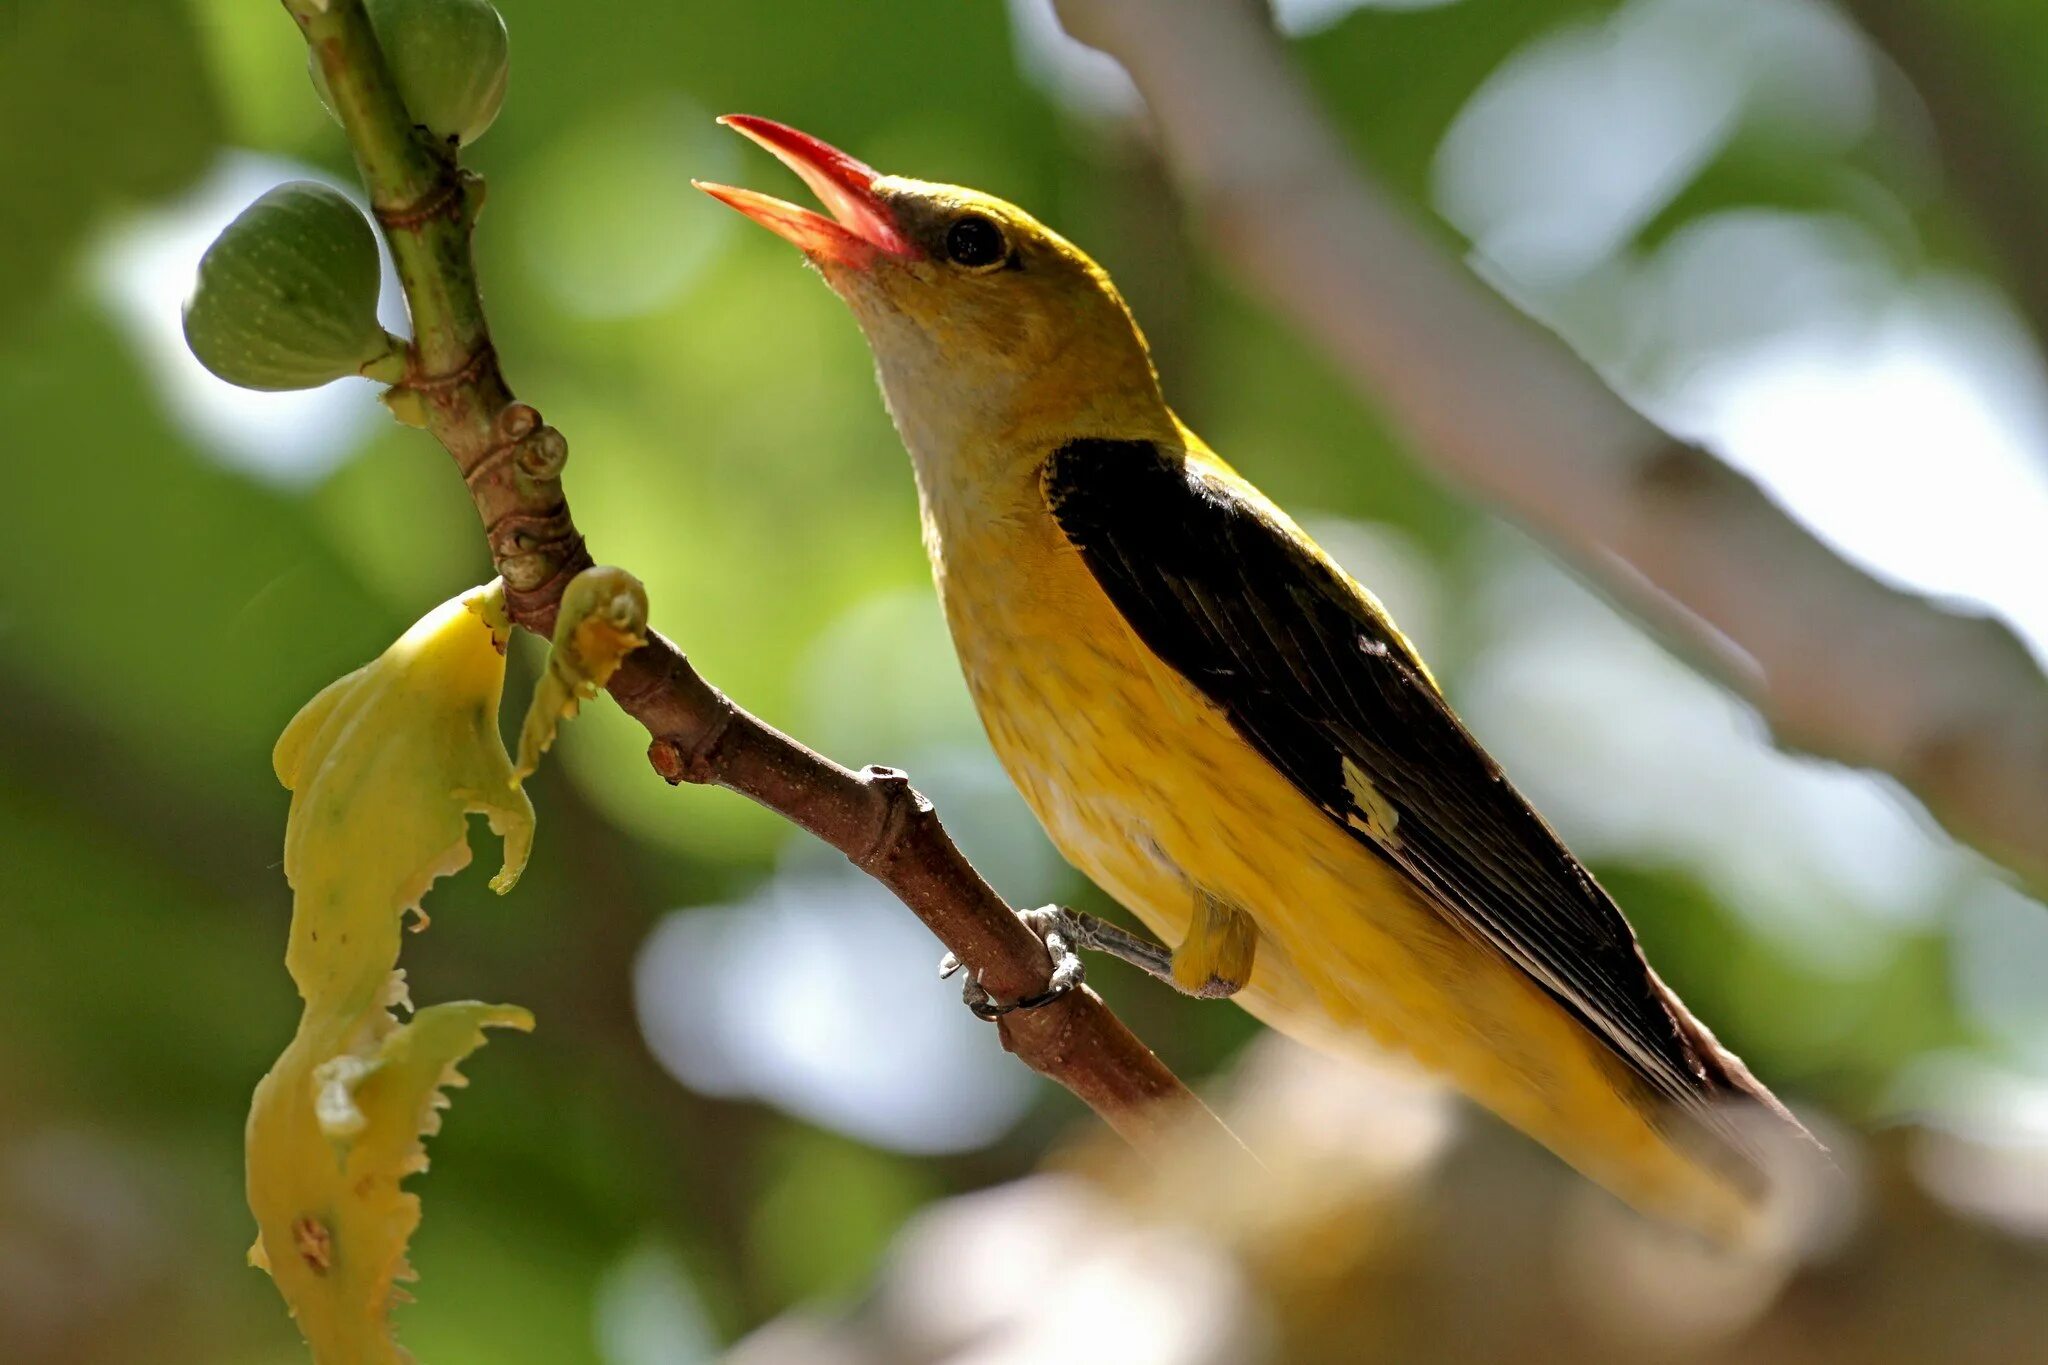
<box><xmin>0</xmin><ymin>0</ymin><xmax>2048</xmax><ymax>1365</ymax></box>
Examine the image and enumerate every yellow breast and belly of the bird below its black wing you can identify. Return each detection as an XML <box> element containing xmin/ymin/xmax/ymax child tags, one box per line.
<box><xmin>934</xmin><ymin>499</ymin><xmax>1743</xmax><ymax>1234</ymax></box>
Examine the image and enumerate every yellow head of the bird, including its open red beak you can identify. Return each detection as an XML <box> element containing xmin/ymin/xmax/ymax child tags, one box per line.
<box><xmin>698</xmin><ymin>115</ymin><xmax>1171</xmax><ymax>487</ymax></box>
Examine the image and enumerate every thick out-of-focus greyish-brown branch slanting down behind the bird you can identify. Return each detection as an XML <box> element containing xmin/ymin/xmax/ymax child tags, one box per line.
<box><xmin>1057</xmin><ymin>0</ymin><xmax>2048</xmax><ymax>888</ymax></box>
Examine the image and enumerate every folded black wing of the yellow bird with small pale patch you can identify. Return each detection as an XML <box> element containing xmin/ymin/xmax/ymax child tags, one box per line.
<box><xmin>1042</xmin><ymin>440</ymin><xmax>1769</xmax><ymax>1128</ymax></box>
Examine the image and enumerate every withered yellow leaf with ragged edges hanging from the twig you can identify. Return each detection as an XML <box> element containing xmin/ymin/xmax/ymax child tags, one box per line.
<box><xmin>248</xmin><ymin>583</ymin><xmax>532</xmax><ymax>1365</ymax></box>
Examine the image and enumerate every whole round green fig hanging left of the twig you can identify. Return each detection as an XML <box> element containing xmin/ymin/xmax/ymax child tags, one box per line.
<box><xmin>184</xmin><ymin>180</ymin><xmax>393</xmax><ymax>389</ymax></box>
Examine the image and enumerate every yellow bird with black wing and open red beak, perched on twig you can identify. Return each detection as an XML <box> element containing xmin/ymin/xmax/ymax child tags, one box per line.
<box><xmin>702</xmin><ymin>115</ymin><xmax>1810</xmax><ymax>1240</ymax></box>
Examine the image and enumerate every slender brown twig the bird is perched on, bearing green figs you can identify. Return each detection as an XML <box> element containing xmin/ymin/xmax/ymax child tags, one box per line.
<box><xmin>285</xmin><ymin>0</ymin><xmax>1217</xmax><ymax>1144</ymax></box>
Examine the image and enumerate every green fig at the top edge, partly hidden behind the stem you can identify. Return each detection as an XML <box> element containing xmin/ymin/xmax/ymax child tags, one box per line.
<box><xmin>319</xmin><ymin>0</ymin><xmax>512</xmax><ymax>145</ymax></box>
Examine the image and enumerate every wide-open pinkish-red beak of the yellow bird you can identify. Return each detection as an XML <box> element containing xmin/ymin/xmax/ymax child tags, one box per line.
<box><xmin>690</xmin><ymin>115</ymin><xmax>924</xmax><ymax>268</ymax></box>
